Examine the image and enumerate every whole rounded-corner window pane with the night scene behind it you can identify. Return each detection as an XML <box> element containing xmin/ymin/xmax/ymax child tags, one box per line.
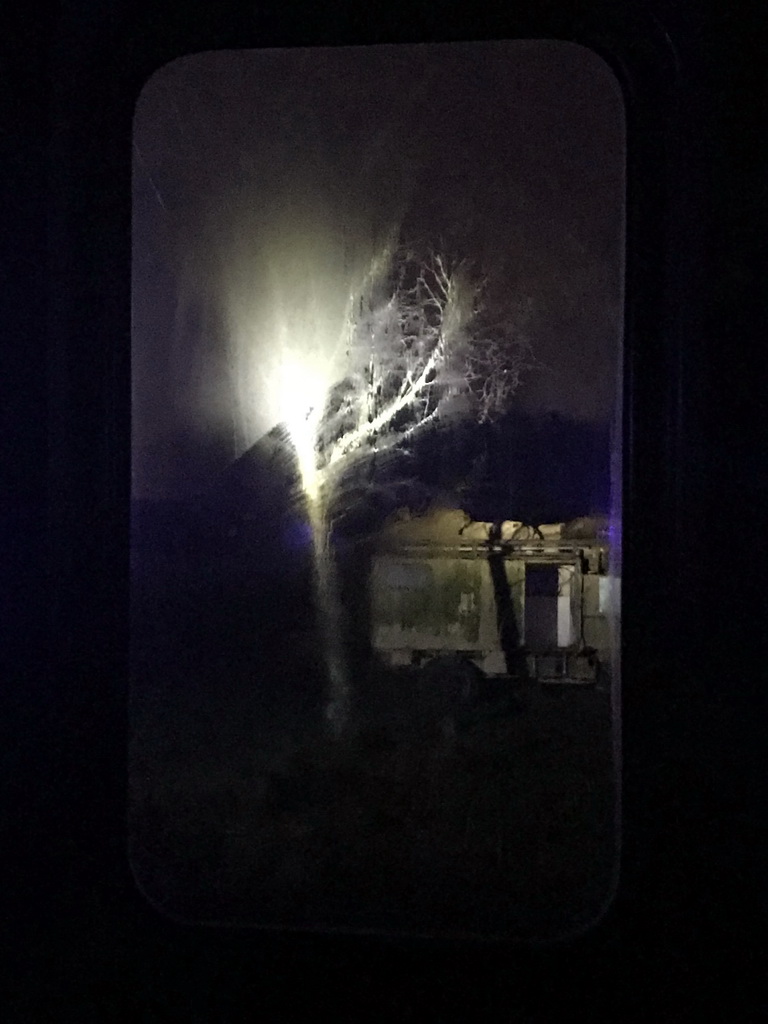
<box><xmin>129</xmin><ymin>41</ymin><xmax>625</xmax><ymax>939</ymax></box>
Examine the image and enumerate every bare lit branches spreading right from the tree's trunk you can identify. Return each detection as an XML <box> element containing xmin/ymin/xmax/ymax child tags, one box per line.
<box><xmin>315</xmin><ymin>241</ymin><xmax>538</xmax><ymax>493</ymax></box>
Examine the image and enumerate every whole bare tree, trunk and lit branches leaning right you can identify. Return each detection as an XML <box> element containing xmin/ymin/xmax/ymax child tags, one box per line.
<box><xmin>280</xmin><ymin>240</ymin><xmax>537</xmax><ymax>735</ymax></box>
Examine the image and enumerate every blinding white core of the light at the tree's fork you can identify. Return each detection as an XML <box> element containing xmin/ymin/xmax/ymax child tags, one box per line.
<box><xmin>276</xmin><ymin>356</ymin><xmax>328</xmax><ymax>501</ymax></box>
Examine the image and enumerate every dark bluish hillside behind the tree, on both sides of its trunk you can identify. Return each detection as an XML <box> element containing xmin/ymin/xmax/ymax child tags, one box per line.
<box><xmin>136</xmin><ymin>412</ymin><xmax>610</xmax><ymax>571</ymax></box>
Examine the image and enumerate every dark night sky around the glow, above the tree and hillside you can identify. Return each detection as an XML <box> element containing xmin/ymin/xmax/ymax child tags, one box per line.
<box><xmin>133</xmin><ymin>42</ymin><xmax>625</xmax><ymax>497</ymax></box>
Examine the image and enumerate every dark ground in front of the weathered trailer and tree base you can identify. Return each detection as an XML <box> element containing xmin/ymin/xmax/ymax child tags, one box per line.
<box><xmin>130</xmin><ymin>636</ymin><xmax>617</xmax><ymax>938</ymax></box>
